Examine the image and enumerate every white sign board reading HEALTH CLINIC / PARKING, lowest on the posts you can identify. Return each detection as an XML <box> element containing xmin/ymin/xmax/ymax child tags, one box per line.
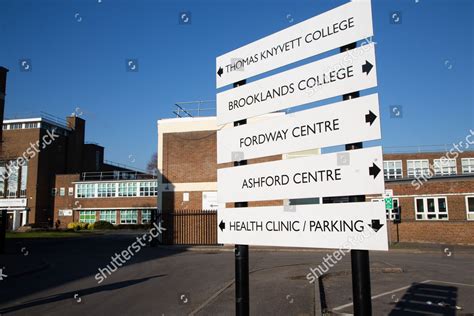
<box><xmin>217</xmin><ymin>202</ymin><xmax>388</xmax><ymax>251</ymax></box>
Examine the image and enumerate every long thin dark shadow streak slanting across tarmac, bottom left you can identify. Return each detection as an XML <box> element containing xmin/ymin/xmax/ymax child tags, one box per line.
<box><xmin>0</xmin><ymin>274</ymin><xmax>166</xmax><ymax>313</ymax></box>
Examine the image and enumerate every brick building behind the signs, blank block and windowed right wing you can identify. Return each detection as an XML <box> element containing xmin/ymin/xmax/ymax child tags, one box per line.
<box><xmin>158</xmin><ymin>113</ymin><xmax>474</xmax><ymax>244</ymax></box>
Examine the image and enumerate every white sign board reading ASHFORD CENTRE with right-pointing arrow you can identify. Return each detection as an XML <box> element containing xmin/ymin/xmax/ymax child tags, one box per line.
<box><xmin>217</xmin><ymin>146</ymin><xmax>384</xmax><ymax>202</ymax></box>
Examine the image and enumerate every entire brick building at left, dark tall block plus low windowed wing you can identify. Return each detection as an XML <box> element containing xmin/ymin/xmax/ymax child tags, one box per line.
<box><xmin>0</xmin><ymin>67</ymin><xmax>156</xmax><ymax>230</ymax></box>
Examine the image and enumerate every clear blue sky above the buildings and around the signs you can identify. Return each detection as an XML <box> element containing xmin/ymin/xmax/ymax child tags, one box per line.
<box><xmin>0</xmin><ymin>0</ymin><xmax>474</xmax><ymax>168</ymax></box>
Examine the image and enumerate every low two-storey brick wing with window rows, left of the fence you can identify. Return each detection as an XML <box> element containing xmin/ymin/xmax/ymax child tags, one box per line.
<box><xmin>53</xmin><ymin>171</ymin><xmax>157</xmax><ymax>228</ymax></box>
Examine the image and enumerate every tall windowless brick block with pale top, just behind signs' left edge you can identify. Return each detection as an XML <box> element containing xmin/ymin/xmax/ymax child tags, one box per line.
<box><xmin>158</xmin><ymin>113</ymin><xmax>320</xmax><ymax>212</ymax></box>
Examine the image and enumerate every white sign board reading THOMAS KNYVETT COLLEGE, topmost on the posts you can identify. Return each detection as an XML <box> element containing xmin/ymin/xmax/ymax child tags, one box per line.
<box><xmin>216</xmin><ymin>1</ymin><xmax>373</xmax><ymax>88</ymax></box>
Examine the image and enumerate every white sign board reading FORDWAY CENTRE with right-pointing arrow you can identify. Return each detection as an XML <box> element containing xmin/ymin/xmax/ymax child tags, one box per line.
<box><xmin>217</xmin><ymin>94</ymin><xmax>381</xmax><ymax>163</ymax></box>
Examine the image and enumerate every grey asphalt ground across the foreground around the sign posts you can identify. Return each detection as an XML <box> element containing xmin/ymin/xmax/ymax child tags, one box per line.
<box><xmin>0</xmin><ymin>233</ymin><xmax>474</xmax><ymax>315</ymax></box>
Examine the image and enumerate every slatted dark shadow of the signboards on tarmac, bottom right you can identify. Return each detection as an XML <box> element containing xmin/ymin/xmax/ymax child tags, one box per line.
<box><xmin>389</xmin><ymin>283</ymin><xmax>458</xmax><ymax>316</ymax></box>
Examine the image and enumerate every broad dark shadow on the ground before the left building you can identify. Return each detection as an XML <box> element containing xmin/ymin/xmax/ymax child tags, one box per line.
<box><xmin>0</xmin><ymin>232</ymin><xmax>186</xmax><ymax>309</ymax></box>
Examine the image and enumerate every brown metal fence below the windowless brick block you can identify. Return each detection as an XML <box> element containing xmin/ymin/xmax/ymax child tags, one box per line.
<box><xmin>158</xmin><ymin>210</ymin><xmax>217</xmax><ymax>245</ymax></box>
